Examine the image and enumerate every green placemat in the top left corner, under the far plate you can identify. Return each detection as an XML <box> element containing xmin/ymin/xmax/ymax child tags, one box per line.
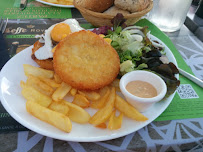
<box><xmin>0</xmin><ymin>0</ymin><xmax>72</xmax><ymax>19</ymax></box>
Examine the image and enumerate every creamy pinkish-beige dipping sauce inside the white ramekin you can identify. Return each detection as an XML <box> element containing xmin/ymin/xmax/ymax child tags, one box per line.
<box><xmin>126</xmin><ymin>80</ymin><xmax>157</xmax><ymax>98</ymax></box>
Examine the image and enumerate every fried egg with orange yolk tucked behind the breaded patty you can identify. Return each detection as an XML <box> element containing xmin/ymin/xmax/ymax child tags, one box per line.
<box><xmin>35</xmin><ymin>19</ymin><xmax>84</xmax><ymax>60</ymax></box>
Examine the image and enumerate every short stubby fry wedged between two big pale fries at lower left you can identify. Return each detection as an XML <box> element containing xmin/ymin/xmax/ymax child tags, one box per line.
<box><xmin>48</xmin><ymin>101</ymin><xmax>69</xmax><ymax>115</ymax></box>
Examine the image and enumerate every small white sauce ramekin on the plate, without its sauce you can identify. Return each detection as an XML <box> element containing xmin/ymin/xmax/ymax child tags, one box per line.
<box><xmin>120</xmin><ymin>70</ymin><xmax>167</xmax><ymax>112</ymax></box>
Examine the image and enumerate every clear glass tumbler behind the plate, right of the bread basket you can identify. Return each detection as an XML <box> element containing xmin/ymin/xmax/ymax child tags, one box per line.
<box><xmin>148</xmin><ymin>0</ymin><xmax>192</xmax><ymax>32</ymax></box>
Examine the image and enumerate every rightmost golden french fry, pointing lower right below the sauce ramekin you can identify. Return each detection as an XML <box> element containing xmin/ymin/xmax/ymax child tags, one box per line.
<box><xmin>115</xmin><ymin>95</ymin><xmax>148</xmax><ymax>121</ymax></box>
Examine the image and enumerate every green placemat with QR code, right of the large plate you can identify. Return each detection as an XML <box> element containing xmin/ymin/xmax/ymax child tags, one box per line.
<box><xmin>136</xmin><ymin>19</ymin><xmax>203</xmax><ymax>121</ymax></box>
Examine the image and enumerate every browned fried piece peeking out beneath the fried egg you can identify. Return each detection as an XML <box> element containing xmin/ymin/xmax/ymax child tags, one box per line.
<box><xmin>32</xmin><ymin>41</ymin><xmax>54</xmax><ymax>70</ymax></box>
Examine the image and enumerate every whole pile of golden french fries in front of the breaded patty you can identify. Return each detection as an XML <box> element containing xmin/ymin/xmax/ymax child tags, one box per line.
<box><xmin>20</xmin><ymin>64</ymin><xmax>147</xmax><ymax>132</ymax></box>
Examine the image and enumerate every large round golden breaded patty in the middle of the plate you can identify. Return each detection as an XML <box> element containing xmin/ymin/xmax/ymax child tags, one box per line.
<box><xmin>53</xmin><ymin>31</ymin><xmax>120</xmax><ymax>90</ymax></box>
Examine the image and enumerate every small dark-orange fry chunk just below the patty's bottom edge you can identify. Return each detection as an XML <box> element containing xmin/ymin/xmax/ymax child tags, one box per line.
<box><xmin>72</xmin><ymin>94</ymin><xmax>90</xmax><ymax>108</ymax></box>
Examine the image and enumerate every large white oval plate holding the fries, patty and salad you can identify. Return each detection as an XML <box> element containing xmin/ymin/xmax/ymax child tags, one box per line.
<box><xmin>0</xmin><ymin>36</ymin><xmax>179</xmax><ymax>142</ymax></box>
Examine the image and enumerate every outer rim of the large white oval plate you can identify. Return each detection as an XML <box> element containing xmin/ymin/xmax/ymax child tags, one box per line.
<box><xmin>0</xmin><ymin>35</ymin><xmax>179</xmax><ymax>142</ymax></box>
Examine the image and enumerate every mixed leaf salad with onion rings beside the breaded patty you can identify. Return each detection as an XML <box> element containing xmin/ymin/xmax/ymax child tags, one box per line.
<box><xmin>93</xmin><ymin>14</ymin><xmax>180</xmax><ymax>95</ymax></box>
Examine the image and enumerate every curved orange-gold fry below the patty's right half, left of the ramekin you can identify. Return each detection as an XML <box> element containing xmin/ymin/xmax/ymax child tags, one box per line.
<box><xmin>90</xmin><ymin>87</ymin><xmax>110</xmax><ymax>109</ymax></box>
